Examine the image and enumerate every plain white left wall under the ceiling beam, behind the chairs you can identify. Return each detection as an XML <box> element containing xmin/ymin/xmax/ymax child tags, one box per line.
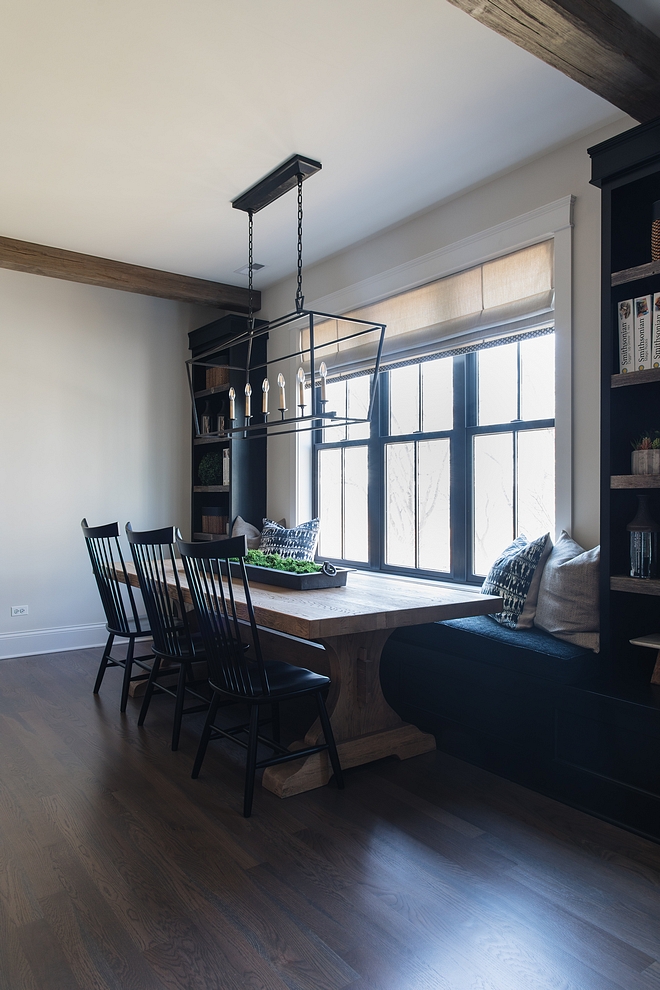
<box><xmin>0</xmin><ymin>270</ymin><xmax>216</xmax><ymax>657</ymax></box>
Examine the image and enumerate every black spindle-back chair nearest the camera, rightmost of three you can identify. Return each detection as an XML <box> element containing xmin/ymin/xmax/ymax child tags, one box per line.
<box><xmin>177</xmin><ymin>536</ymin><xmax>344</xmax><ymax>818</ymax></box>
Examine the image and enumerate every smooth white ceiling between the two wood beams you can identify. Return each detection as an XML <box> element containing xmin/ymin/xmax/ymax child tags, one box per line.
<box><xmin>0</xmin><ymin>0</ymin><xmax>628</xmax><ymax>287</ymax></box>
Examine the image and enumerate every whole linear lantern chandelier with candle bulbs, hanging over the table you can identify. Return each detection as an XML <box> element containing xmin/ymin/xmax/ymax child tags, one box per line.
<box><xmin>186</xmin><ymin>155</ymin><xmax>386</xmax><ymax>438</ymax></box>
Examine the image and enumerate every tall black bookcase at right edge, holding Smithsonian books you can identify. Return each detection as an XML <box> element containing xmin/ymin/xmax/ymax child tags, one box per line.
<box><xmin>589</xmin><ymin>118</ymin><xmax>660</xmax><ymax>680</ymax></box>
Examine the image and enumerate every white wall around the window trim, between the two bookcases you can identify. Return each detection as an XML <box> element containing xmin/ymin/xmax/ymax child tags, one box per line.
<box><xmin>262</xmin><ymin>120</ymin><xmax>635</xmax><ymax>547</ymax></box>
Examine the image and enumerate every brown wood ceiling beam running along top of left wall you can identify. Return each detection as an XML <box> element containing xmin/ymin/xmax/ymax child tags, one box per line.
<box><xmin>0</xmin><ymin>237</ymin><xmax>261</xmax><ymax>313</ymax></box>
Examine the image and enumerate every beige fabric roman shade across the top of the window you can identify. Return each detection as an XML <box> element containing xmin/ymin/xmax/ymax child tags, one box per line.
<box><xmin>303</xmin><ymin>240</ymin><xmax>554</xmax><ymax>377</ymax></box>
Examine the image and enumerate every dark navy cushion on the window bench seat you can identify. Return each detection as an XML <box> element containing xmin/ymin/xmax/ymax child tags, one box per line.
<box><xmin>392</xmin><ymin>615</ymin><xmax>599</xmax><ymax>684</ymax></box>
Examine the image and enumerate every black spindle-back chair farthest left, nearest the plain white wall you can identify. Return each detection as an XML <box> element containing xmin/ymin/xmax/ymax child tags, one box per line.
<box><xmin>80</xmin><ymin>519</ymin><xmax>152</xmax><ymax>712</ymax></box>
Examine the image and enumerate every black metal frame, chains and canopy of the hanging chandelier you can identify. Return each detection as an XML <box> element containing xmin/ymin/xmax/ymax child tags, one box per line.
<box><xmin>186</xmin><ymin>155</ymin><xmax>386</xmax><ymax>438</ymax></box>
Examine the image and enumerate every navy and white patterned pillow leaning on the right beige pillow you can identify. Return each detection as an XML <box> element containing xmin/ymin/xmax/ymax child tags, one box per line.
<box><xmin>481</xmin><ymin>533</ymin><xmax>552</xmax><ymax>629</ymax></box>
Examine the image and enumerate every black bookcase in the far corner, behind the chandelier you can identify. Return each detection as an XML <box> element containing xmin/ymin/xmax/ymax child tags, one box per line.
<box><xmin>188</xmin><ymin>315</ymin><xmax>267</xmax><ymax>539</ymax></box>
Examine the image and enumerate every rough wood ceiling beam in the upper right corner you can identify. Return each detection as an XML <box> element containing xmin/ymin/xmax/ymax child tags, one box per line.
<box><xmin>449</xmin><ymin>0</ymin><xmax>660</xmax><ymax>123</ymax></box>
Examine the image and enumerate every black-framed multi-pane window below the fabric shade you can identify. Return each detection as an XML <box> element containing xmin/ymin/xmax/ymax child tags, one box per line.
<box><xmin>314</xmin><ymin>334</ymin><xmax>555</xmax><ymax>581</ymax></box>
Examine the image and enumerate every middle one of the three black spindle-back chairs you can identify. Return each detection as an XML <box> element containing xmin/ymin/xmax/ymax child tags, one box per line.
<box><xmin>126</xmin><ymin>523</ymin><xmax>209</xmax><ymax>750</ymax></box>
